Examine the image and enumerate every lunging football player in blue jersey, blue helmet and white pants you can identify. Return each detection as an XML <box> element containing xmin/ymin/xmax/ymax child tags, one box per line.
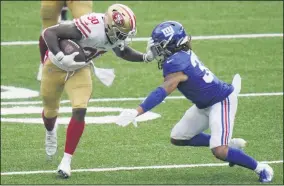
<box><xmin>116</xmin><ymin>21</ymin><xmax>273</xmax><ymax>182</ymax></box>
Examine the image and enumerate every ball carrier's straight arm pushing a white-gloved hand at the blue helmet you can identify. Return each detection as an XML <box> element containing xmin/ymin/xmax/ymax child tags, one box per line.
<box><xmin>113</xmin><ymin>46</ymin><xmax>154</xmax><ymax>62</ymax></box>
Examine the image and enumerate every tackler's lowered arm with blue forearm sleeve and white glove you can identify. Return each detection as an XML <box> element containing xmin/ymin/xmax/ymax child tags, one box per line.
<box><xmin>116</xmin><ymin>72</ymin><xmax>188</xmax><ymax>127</ymax></box>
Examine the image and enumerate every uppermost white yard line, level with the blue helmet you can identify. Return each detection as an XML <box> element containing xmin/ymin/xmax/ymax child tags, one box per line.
<box><xmin>1</xmin><ymin>33</ymin><xmax>283</xmax><ymax>46</ymax></box>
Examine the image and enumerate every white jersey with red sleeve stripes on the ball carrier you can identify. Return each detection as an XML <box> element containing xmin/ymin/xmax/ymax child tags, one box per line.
<box><xmin>73</xmin><ymin>13</ymin><xmax>124</xmax><ymax>58</ymax></box>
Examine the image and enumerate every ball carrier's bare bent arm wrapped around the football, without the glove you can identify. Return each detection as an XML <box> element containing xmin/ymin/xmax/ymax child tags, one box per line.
<box><xmin>42</xmin><ymin>23</ymin><xmax>82</xmax><ymax>55</ymax></box>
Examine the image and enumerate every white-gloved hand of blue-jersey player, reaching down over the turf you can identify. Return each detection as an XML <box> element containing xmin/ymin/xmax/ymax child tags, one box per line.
<box><xmin>116</xmin><ymin>109</ymin><xmax>138</xmax><ymax>127</ymax></box>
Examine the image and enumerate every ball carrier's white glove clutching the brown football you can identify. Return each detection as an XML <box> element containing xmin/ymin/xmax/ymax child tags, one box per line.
<box><xmin>48</xmin><ymin>51</ymin><xmax>88</xmax><ymax>71</ymax></box>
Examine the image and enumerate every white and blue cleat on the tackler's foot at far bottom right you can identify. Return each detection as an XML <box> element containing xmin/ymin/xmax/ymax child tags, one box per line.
<box><xmin>255</xmin><ymin>163</ymin><xmax>274</xmax><ymax>183</ymax></box>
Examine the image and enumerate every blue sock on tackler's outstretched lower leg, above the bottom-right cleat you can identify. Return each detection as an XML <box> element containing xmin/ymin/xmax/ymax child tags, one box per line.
<box><xmin>225</xmin><ymin>147</ymin><xmax>257</xmax><ymax>170</ymax></box>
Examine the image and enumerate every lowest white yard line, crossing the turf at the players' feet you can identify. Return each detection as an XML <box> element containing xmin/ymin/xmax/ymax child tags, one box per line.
<box><xmin>1</xmin><ymin>160</ymin><xmax>283</xmax><ymax>176</ymax></box>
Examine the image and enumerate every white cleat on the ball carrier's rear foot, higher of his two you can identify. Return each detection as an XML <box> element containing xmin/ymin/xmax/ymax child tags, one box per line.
<box><xmin>45</xmin><ymin>123</ymin><xmax>57</xmax><ymax>159</ymax></box>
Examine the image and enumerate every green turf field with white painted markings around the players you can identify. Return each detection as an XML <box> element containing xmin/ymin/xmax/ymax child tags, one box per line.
<box><xmin>1</xmin><ymin>1</ymin><xmax>283</xmax><ymax>185</ymax></box>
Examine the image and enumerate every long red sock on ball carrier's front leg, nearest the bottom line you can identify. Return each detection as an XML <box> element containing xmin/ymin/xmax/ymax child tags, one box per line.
<box><xmin>65</xmin><ymin>117</ymin><xmax>85</xmax><ymax>155</ymax></box>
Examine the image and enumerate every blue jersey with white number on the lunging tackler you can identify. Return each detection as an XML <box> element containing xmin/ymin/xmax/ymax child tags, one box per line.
<box><xmin>163</xmin><ymin>51</ymin><xmax>234</xmax><ymax>109</ymax></box>
